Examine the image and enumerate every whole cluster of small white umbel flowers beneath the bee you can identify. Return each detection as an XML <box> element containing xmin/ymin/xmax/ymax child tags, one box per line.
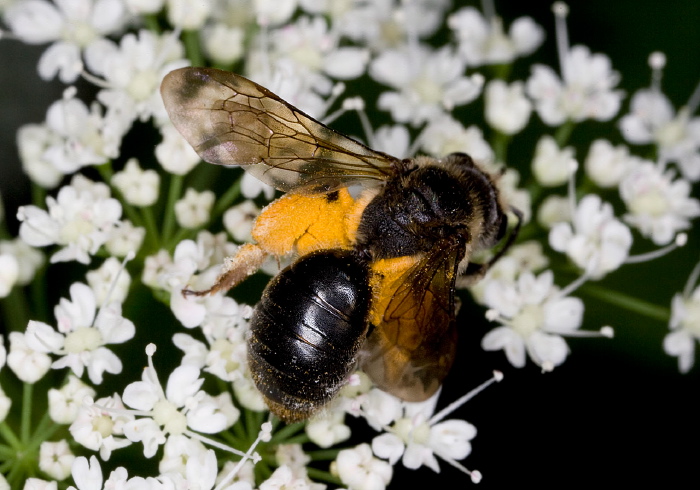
<box><xmin>0</xmin><ymin>0</ymin><xmax>700</xmax><ymax>490</ymax></box>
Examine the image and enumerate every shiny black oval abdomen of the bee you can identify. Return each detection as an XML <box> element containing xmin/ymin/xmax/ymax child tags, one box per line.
<box><xmin>248</xmin><ymin>250</ymin><xmax>372</xmax><ymax>421</ymax></box>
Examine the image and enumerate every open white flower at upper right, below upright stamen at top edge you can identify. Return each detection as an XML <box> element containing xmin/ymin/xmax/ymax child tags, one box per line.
<box><xmin>526</xmin><ymin>46</ymin><xmax>623</xmax><ymax>126</ymax></box>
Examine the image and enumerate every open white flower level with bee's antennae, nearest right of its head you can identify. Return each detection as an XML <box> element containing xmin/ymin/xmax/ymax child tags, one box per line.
<box><xmin>549</xmin><ymin>194</ymin><xmax>632</xmax><ymax>279</ymax></box>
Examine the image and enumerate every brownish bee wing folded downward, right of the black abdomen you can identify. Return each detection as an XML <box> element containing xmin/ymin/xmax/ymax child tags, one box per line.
<box><xmin>361</xmin><ymin>239</ymin><xmax>464</xmax><ymax>401</ymax></box>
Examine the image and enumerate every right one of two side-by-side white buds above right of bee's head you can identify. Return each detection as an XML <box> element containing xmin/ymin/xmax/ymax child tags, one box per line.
<box><xmin>584</xmin><ymin>139</ymin><xmax>641</xmax><ymax>188</ymax></box>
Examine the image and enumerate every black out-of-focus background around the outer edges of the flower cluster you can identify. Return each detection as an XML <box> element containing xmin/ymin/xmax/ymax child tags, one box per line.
<box><xmin>0</xmin><ymin>0</ymin><xmax>700</xmax><ymax>488</ymax></box>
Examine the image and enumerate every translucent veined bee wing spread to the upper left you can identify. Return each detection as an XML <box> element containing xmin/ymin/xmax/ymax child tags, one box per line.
<box><xmin>161</xmin><ymin>68</ymin><xmax>399</xmax><ymax>192</ymax></box>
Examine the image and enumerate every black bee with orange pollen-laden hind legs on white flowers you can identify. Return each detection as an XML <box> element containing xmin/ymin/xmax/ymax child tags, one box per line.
<box><xmin>161</xmin><ymin>68</ymin><xmax>522</xmax><ymax>422</ymax></box>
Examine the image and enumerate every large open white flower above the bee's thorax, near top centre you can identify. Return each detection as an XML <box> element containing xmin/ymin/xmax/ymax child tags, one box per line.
<box><xmin>369</xmin><ymin>45</ymin><xmax>483</xmax><ymax>126</ymax></box>
